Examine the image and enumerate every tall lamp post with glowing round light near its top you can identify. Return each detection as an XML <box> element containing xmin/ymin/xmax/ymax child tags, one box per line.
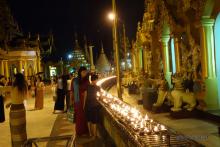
<box><xmin>108</xmin><ymin>0</ymin><xmax>122</xmax><ymax>99</ymax></box>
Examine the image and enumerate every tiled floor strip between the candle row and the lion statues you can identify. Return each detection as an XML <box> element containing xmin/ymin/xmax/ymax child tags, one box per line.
<box><xmin>110</xmin><ymin>87</ymin><xmax>220</xmax><ymax>147</ymax></box>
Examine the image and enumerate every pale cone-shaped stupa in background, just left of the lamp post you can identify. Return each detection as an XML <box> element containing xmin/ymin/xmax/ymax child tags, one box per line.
<box><xmin>96</xmin><ymin>45</ymin><xmax>111</xmax><ymax>72</ymax></box>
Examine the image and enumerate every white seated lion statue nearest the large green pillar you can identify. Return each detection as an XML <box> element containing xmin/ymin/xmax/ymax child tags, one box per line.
<box><xmin>171</xmin><ymin>73</ymin><xmax>196</xmax><ymax>112</ymax></box>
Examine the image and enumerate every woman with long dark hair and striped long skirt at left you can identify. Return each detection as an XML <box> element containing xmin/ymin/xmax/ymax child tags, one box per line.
<box><xmin>7</xmin><ymin>73</ymin><xmax>28</xmax><ymax>147</ymax></box>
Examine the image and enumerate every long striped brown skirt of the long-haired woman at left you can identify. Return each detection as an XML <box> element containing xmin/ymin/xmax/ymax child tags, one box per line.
<box><xmin>9</xmin><ymin>104</ymin><xmax>27</xmax><ymax>147</ymax></box>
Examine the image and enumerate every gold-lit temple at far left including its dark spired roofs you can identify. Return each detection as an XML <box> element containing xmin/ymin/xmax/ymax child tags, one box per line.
<box><xmin>0</xmin><ymin>0</ymin><xmax>54</xmax><ymax>79</ymax></box>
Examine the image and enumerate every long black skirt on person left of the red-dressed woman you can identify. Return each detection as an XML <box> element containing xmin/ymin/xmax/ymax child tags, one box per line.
<box><xmin>54</xmin><ymin>89</ymin><xmax>65</xmax><ymax>111</ymax></box>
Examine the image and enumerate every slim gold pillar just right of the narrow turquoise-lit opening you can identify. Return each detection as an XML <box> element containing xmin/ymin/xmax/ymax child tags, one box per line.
<box><xmin>174</xmin><ymin>37</ymin><xmax>181</xmax><ymax>73</ymax></box>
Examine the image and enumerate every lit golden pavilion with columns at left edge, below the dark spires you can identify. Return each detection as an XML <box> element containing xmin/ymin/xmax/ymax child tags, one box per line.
<box><xmin>0</xmin><ymin>37</ymin><xmax>42</xmax><ymax>78</ymax></box>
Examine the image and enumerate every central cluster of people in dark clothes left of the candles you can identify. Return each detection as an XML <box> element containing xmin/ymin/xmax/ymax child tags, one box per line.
<box><xmin>54</xmin><ymin>67</ymin><xmax>100</xmax><ymax>137</ymax></box>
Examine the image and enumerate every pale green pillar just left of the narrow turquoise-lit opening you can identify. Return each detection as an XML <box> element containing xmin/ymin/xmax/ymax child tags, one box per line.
<box><xmin>161</xmin><ymin>35</ymin><xmax>172</xmax><ymax>88</ymax></box>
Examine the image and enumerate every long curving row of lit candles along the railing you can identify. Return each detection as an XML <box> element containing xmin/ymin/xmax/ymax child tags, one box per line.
<box><xmin>97</xmin><ymin>77</ymin><xmax>167</xmax><ymax>135</ymax></box>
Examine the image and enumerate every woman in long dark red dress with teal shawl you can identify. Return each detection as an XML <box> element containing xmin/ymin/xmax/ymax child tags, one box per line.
<box><xmin>71</xmin><ymin>67</ymin><xmax>89</xmax><ymax>136</ymax></box>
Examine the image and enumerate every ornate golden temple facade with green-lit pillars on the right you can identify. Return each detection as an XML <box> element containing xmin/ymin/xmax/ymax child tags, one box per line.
<box><xmin>132</xmin><ymin>0</ymin><xmax>220</xmax><ymax>109</ymax></box>
